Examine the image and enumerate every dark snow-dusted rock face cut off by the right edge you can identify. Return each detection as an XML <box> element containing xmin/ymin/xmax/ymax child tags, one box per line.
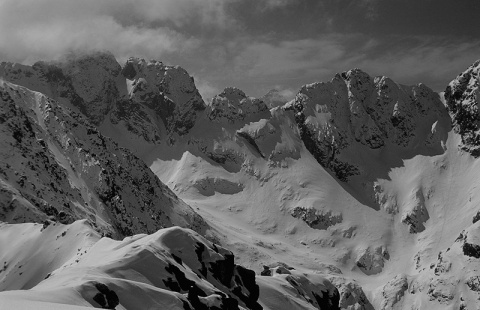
<box><xmin>444</xmin><ymin>60</ymin><xmax>480</xmax><ymax>157</ymax></box>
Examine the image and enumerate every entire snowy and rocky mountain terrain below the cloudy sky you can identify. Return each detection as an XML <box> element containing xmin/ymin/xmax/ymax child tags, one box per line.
<box><xmin>0</xmin><ymin>53</ymin><xmax>480</xmax><ymax>309</ymax></box>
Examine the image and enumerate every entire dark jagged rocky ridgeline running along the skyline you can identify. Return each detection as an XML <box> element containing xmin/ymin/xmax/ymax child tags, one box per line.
<box><xmin>0</xmin><ymin>53</ymin><xmax>464</xmax><ymax>181</ymax></box>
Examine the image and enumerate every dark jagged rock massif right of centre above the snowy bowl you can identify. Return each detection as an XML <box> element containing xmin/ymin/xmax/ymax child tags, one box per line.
<box><xmin>287</xmin><ymin>69</ymin><xmax>446</xmax><ymax>181</ymax></box>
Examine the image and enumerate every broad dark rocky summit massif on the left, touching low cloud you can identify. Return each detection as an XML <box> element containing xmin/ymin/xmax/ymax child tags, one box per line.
<box><xmin>0</xmin><ymin>52</ymin><xmax>206</xmax><ymax>143</ymax></box>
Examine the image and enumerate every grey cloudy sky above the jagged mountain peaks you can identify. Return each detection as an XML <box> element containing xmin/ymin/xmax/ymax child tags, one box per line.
<box><xmin>0</xmin><ymin>0</ymin><xmax>480</xmax><ymax>98</ymax></box>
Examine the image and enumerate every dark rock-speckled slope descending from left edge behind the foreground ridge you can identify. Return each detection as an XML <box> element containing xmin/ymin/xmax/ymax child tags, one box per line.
<box><xmin>0</xmin><ymin>82</ymin><xmax>206</xmax><ymax>236</ymax></box>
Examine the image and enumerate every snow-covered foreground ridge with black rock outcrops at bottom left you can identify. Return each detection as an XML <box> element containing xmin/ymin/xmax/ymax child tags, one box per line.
<box><xmin>0</xmin><ymin>221</ymin><xmax>339</xmax><ymax>310</ymax></box>
